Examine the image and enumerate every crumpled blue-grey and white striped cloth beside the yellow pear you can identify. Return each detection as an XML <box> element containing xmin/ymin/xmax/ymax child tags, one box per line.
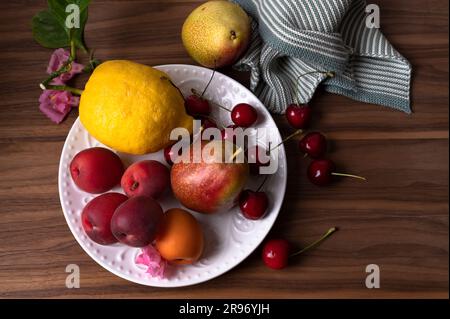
<box><xmin>233</xmin><ymin>0</ymin><xmax>412</xmax><ymax>113</ymax></box>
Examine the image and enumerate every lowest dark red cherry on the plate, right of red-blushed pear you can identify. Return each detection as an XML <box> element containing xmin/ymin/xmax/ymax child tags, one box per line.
<box><xmin>239</xmin><ymin>189</ymin><xmax>269</xmax><ymax>220</ymax></box>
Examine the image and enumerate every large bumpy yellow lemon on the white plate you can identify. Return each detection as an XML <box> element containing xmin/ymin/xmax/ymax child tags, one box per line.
<box><xmin>79</xmin><ymin>60</ymin><xmax>193</xmax><ymax>155</ymax></box>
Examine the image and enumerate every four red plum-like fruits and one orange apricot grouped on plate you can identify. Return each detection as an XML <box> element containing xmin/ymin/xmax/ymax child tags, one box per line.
<box><xmin>70</xmin><ymin>147</ymin><xmax>203</xmax><ymax>264</ymax></box>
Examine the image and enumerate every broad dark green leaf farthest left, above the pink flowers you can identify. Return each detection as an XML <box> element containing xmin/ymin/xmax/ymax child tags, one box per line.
<box><xmin>31</xmin><ymin>10</ymin><xmax>70</xmax><ymax>49</ymax></box>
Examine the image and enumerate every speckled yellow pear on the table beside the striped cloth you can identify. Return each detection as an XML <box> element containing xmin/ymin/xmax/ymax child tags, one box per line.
<box><xmin>181</xmin><ymin>1</ymin><xmax>251</xmax><ymax>68</ymax></box>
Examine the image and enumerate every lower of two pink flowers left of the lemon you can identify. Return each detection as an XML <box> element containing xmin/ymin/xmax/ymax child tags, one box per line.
<box><xmin>39</xmin><ymin>90</ymin><xmax>80</xmax><ymax>124</ymax></box>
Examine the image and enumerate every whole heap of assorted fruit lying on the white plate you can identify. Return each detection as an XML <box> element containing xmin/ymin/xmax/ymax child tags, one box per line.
<box><xmin>69</xmin><ymin>61</ymin><xmax>269</xmax><ymax>276</ymax></box>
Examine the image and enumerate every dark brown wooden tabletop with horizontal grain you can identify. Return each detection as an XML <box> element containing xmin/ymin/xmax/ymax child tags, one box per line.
<box><xmin>0</xmin><ymin>0</ymin><xmax>449</xmax><ymax>298</ymax></box>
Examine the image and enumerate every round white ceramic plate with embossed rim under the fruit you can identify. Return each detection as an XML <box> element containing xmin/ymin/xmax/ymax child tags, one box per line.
<box><xmin>58</xmin><ymin>65</ymin><xmax>287</xmax><ymax>287</ymax></box>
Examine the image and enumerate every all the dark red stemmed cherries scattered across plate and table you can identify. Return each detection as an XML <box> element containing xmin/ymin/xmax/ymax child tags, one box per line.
<box><xmin>164</xmin><ymin>71</ymin><xmax>365</xmax><ymax>269</ymax></box>
